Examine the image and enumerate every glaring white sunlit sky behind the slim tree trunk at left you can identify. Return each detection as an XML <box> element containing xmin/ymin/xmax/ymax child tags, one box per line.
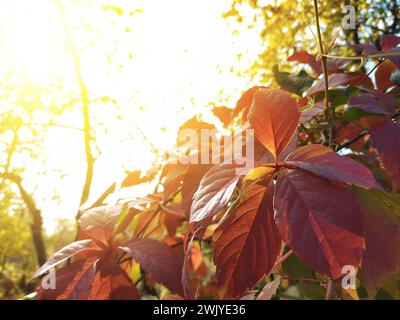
<box><xmin>0</xmin><ymin>0</ymin><xmax>262</xmax><ymax>232</ymax></box>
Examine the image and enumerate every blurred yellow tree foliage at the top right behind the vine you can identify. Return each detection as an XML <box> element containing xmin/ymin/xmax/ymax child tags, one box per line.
<box><xmin>224</xmin><ymin>0</ymin><xmax>400</xmax><ymax>84</ymax></box>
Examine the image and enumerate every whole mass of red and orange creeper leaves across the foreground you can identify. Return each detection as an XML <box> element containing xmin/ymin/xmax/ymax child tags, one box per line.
<box><xmin>34</xmin><ymin>36</ymin><xmax>400</xmax><ymax>299</ymax></box>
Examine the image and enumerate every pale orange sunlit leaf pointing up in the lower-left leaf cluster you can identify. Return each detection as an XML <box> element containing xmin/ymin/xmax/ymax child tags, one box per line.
<box><xmin>79</xmin><ymin>206</ymin><xmax>121</xmax><ymax>244</ymax></box>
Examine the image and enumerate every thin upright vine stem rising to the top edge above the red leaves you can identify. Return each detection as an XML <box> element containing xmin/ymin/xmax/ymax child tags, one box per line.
<box><xmin>314</xmin><ymin>0</ymin><xmax>335</xmax><ymax>147</ymax></box>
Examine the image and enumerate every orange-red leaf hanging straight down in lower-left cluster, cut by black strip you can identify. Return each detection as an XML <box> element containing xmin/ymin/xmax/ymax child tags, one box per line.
<box><xmin>89</xmin><ymin>255</ymin><xmax>140</xmax><ymax>300</ymax></box>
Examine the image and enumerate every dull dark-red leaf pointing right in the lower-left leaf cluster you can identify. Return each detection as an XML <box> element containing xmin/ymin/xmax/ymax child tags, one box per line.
<box><xmin>119</xmin><ymin>239</ymin><xmax>183</xmax><ymax>295</ymax></box>
